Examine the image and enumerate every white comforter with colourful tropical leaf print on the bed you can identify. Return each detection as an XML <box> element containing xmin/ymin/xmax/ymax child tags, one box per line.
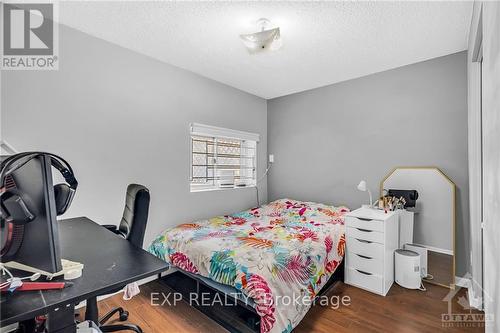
<box><xmin>149</xmin><ymin>199</ymin><xmax>349</xmax><ymax>333</ymax></box>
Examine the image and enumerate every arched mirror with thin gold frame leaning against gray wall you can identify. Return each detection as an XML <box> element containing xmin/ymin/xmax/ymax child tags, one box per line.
<box><xmin>380</xmin><ymin>167</ymin><xmax>456</xmax><ymax>288</ymax></box>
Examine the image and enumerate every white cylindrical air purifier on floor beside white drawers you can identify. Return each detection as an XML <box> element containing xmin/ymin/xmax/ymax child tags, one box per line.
<box><xmin>394</xmin><ymin>250</ymin><xmax>422</xmax><ymax>289</ymax></box>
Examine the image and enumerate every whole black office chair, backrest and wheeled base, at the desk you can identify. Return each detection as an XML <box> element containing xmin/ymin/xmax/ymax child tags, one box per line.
<box><xmin>85</xmin><ymin>184</ymin><xmax>150</xmax><ymax>333</ymax></box>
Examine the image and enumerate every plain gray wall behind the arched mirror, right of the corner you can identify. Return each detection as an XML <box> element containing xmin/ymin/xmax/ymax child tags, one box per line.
<box><xmin>267</xmin><ymin>52</ymin><xmax>469</xmax><ymax>276</ymax></box>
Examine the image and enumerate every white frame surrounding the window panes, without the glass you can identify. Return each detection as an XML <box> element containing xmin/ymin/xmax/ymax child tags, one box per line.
<box><xmin>189</xmin><ymin>123</ymin><xmax>260</xmax><ymax>192</ymax></box>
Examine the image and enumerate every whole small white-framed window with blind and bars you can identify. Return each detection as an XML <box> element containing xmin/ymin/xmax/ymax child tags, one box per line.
<box><xmin>190</xmin><ymin>124</ymin><xmax>259</xmax><ymax>192</ymax></box>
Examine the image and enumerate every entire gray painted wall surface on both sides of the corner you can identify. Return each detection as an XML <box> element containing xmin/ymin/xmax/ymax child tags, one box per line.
<box><xmin>0</xmin><ymin>26</ymin><xmax>468</xmax><ymax>275</ymax></box>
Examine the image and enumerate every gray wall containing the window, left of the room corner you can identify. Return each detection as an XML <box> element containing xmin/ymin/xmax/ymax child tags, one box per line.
<box><xmin>1</xmin><ymin>26</ymin><xmax>267</xmax><ymax>245</ymax></box>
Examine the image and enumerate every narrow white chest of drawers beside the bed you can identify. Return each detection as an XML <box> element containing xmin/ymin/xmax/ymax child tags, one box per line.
<box><xmin>344</xmin><ymin>208</ymin><xmax>399</xmax><ymax>296</ymax></box>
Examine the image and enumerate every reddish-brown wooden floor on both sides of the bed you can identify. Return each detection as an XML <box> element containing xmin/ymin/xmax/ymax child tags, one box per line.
<box><xmin>80</xmin><ymin>281</ymin><xmax>484</xmax><ymax>333</ymax></box>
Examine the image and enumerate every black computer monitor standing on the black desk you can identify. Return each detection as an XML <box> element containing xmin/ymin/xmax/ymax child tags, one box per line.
<box><xmin>0</xmin><ymin>155</ymin><xmax>62</xmax><ymax>273</ymax></box>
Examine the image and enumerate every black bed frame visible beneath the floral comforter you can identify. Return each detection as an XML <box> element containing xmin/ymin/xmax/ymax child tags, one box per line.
<box><xmin>159</xmin><ymin>260</ymin><xmax>344</xmax><ymax>333</ymax></box>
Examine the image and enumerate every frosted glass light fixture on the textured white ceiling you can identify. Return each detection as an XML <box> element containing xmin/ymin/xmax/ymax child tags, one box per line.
<box><xmin>240</xmin><ymin>18</ymin><xmax>281</xmax><ymax>53</ymax></box>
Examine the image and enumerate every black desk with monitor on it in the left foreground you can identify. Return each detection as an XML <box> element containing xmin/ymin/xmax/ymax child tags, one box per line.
<box><xmin>0</xmin><ymin>217</ymin><xmax>168</xmax><ymax>331</ymax></box>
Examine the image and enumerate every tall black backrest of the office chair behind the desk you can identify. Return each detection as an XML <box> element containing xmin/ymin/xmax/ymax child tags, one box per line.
<box><xmin>118</xmin><ymin>184</ymin><xmax>150</xmax><ymax>247</ymax></box>
